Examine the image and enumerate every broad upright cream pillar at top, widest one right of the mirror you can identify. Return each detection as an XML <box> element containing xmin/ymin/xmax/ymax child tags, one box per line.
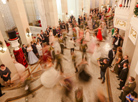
<box><xmin>44</xmin><ymin>0</ymin><xmax>59</xmax><ymax>27</ymax></box>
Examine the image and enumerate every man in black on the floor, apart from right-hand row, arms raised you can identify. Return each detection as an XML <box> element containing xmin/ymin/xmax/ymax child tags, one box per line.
<box><xmin>98</xmin><ymin>58</ymin><xmax>108</xmax><ymax>84</ymax></box>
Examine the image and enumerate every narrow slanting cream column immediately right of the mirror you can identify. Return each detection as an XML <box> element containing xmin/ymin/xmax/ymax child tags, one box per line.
<box><xmin>35</xmin><ymin>0</ymin><xmax>47</xmax><ymax>31</ymax></box>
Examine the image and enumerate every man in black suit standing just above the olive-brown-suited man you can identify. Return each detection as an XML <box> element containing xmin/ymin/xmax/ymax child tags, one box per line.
<box><xmin>117</xmin><ymin>63</ymin><xmax>128</xmax><ymax>90</ymax></box>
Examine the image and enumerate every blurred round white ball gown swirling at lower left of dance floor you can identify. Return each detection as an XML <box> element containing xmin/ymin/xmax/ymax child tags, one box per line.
<box><xmin>40</xmin><ymin>67</ymin><xmax>60</xmax><ymax>88</ymax></box>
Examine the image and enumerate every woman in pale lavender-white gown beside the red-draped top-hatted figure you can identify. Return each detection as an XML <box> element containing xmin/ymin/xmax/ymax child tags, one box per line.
<box><xmin>27</xmin><ymin>45</ymin><xmax>38</xmax><ymax>64</ymax></box>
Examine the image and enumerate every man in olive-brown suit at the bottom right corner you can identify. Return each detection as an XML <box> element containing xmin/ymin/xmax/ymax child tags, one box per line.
<box><xmin>119</xmin><ymin>76</ymin><xmax>136</xmax><ymax>102</ymax></box>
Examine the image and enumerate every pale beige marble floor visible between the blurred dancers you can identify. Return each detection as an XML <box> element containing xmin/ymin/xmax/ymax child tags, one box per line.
<box><xmin>0</xmin><ymin>32</ymin><xmax>122</xmax><ymax>102</ymax></box>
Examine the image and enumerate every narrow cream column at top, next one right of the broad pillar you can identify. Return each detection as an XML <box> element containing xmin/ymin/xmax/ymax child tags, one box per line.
<box><xmin>61</xmin><ymin>0</ymin><xmax>68</xmax><ymax>21</ymax></box>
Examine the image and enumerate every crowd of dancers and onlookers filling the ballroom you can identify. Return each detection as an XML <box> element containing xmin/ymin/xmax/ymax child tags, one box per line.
<box><xmin>0</xmin><ymin>8</ymin><xmax>136</xmax><ymax>102</ymax></box>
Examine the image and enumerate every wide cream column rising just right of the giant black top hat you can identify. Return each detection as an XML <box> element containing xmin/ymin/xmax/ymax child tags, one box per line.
<box><xmin>8</xmin><ymin>0</ymin><xmax>32</xmax><ymax>44</ymax></box>
